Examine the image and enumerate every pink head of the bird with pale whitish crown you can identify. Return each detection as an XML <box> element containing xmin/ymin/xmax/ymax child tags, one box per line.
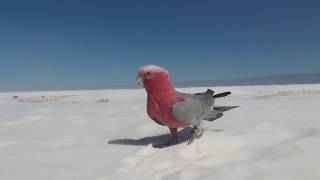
<box><xmin>137</xmin><ymin>65</ymin><xmax>172</xmax><ymax>91</ymax></box>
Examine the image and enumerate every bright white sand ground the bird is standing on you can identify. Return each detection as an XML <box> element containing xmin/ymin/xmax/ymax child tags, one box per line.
<box><xmin>0</xmin><ymin>85</ymin><xmax>320</xmax><ymax>180</ymax></box>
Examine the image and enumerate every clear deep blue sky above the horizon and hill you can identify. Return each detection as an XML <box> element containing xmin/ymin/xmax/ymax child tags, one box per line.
<box><xmin>0</xmin><ymin>0</ymin><xmax>320</xmax><ymax>90</ymax></box>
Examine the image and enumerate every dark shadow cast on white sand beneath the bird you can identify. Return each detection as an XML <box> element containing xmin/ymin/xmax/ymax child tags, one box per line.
<box><xmin>108</xmin><ymin>127</ymin><xmax>192</xmax><ymax>147</ymax></box>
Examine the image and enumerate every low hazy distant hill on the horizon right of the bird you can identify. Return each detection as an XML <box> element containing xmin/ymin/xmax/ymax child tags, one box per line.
<box><xmin>174</xmin><ymin>73</ymin><xmax>320</xmax><ymax>87</ymax></box>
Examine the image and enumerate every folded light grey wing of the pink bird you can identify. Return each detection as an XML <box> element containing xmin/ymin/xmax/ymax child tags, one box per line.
<box><xmin>172</xmin><ymin>96</ymin><xmax>211</xmax><ymax>125</ymax></box>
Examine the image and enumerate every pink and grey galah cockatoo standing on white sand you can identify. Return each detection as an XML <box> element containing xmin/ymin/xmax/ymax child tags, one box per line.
<box><xmin>137</xmin><ymin>65</ymin><xmax>238</xmax><ymax>143</ymax></box>
